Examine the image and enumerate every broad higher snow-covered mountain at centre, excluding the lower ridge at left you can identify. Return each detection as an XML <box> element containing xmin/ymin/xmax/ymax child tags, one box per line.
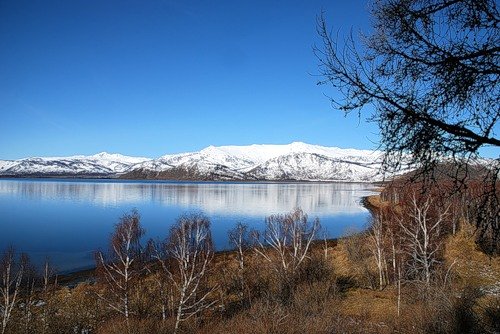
<box><xmin>121</xmin><ymin>142</ymin><xmax>382</xmax><ymax>181</ymax></box>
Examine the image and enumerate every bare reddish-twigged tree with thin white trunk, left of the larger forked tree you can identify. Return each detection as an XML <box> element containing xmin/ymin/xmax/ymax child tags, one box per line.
<box><xmin>96</xmin><ymin>210</ymin><xmax>144</xmax><ymax>320</ymax></box>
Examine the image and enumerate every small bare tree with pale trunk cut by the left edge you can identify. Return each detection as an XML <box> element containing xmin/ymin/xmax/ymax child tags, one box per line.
<box><xmin>0</xmin><ymin>247</ymin><xmax>25</xmax><ymax>334</ymax></box>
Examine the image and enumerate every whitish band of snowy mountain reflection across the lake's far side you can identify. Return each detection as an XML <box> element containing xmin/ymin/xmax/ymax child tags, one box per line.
<box><xmin>0</xmin><ymin>180</ymin><xmax>371</xmax><ymax>216</ymax></box>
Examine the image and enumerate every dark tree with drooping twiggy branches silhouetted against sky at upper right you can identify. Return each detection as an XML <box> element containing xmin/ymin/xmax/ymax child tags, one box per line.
<box><xmin>315</xmin><ymin>0</ymin><xmax>500</xmax><ymax>248</ymax></box>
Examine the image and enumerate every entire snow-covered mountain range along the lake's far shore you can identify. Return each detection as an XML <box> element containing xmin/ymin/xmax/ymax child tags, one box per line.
<box><xmin>0</xmin><ymin>142</ymin><xmax>382</xmax><ymax>182</ymax></box>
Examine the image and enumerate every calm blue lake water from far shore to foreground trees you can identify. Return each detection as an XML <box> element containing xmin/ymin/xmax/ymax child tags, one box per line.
<box><xmin>0</xmin><ymin>179</ymin><xmax>374</xmax><ymax>271</ymax></box>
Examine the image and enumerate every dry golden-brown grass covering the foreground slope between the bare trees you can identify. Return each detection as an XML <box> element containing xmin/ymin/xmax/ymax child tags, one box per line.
<box><xmin>4</xmin><ymin>190</ymin><xmax>500</xmax><ymax>334</ymax></box>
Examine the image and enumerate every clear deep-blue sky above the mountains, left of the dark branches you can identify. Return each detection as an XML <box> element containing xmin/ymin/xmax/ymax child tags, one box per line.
<box><xmin>0</xmin><ymin>0</ymin><xmax>386</xmax><ymax>159</ymax></box>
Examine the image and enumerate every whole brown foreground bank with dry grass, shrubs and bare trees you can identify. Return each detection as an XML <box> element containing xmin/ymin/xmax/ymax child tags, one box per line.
<box><xmin>0</xmin><ymin>183</ymin><xmax>500</xmax><ymax>334</ymax></box>
